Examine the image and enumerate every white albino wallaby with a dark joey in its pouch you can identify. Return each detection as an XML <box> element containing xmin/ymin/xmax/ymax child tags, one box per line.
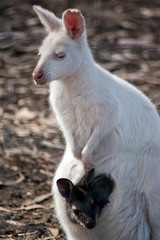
<box><xmin>33</xmin><ymin>6</ymin><xmax>160</xmax><ymax>240</ymax></box>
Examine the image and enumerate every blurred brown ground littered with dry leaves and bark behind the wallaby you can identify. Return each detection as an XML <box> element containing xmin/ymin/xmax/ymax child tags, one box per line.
<box><xmin>0</xmin><ymin>0</ymin><xmax>160</xmax><ymax>240</ymax></box>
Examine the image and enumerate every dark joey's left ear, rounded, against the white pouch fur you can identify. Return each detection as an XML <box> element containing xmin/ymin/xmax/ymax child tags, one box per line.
<box><xmin>57</xmin><ymin>178</ymin><xmax>74</xmax><ymax>199</ymax></box>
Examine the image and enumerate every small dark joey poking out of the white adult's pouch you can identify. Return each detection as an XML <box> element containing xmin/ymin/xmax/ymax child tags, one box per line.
<box><xmin>57</xmin><ymin>169</ymin><xmax>114</xmax><ymax>229</ymax></box>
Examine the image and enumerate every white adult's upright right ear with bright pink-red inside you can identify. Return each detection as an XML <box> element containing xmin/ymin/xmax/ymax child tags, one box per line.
<box><xmin>63</xmin><ymin>9</ymin><xmax>84</xmax><ymax>39</ymax></box>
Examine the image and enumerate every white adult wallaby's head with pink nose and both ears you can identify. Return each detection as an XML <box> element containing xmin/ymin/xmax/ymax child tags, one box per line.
<box><xmin>33</xmin><ymin>6</ymin><xmax>87</xmax><ymax>85</ymax></box>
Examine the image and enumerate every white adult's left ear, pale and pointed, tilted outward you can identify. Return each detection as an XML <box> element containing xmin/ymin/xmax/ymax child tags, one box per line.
<box><xmin>33</xmin><ymin>5</ymin><xmax>62</xmax><ymax>32</ymax></box>
